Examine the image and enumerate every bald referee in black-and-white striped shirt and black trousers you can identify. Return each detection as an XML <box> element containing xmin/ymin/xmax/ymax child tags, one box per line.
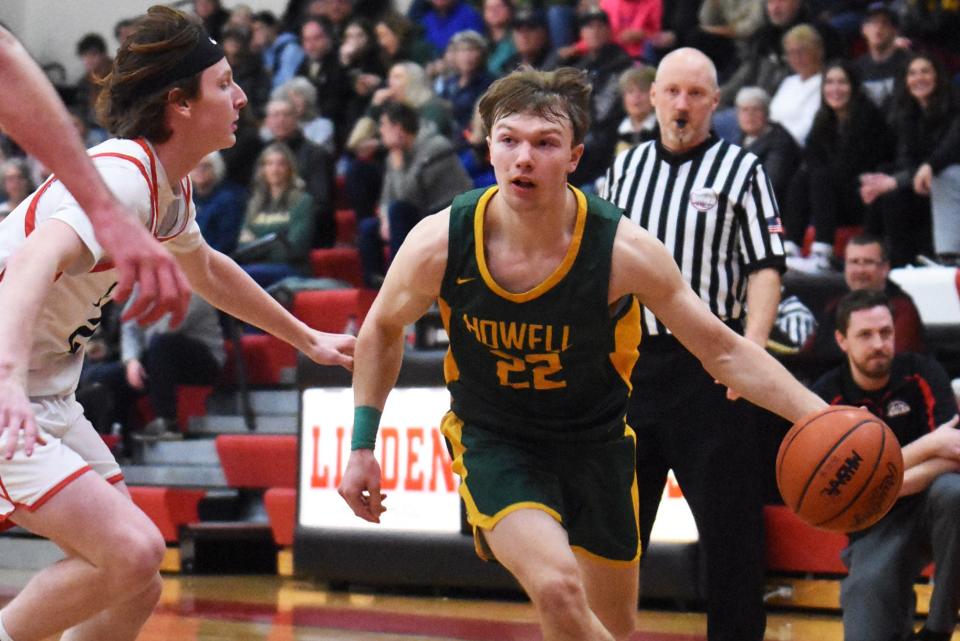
<box><xmin>602</xmin><ymin>48</ymin><xmax>784</xmax><ymax>641</ymax></box>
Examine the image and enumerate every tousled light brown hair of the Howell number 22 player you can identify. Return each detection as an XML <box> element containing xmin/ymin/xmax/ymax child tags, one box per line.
<box><xmin>478</xmin><ymin>66</ymin><xmax>591</xmax><ymax>146</ymax></box>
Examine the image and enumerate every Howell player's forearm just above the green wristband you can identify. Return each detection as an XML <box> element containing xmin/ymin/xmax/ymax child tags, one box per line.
<box><xmin>353</xmin><ymin>316</ymin><xmax>403</xmax><ymax>411</ymax></box>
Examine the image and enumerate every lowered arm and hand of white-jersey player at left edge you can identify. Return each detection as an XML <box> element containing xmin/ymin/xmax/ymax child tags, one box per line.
<box><xmin>0</xmin><ymin>220</ymin><xmax>85</xmax><ymax>459</ymax></box>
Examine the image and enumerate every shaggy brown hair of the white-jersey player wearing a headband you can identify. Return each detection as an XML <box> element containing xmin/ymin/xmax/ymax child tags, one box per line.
<box><xmin>97</xmin><ymin>5</ymin><xmax>206</xmax><ymax>143</ymax></box>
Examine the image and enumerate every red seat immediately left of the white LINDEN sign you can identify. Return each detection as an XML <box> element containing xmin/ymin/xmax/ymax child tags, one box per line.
<box><xmin>216</xmin><ymin>434</ymin><xmax>297</xmax><ymax>489</ymax></box>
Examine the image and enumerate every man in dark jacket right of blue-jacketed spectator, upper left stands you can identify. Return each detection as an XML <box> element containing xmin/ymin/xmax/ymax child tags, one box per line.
<box><xmin>297</xmin><ymin>18</ymin><xmax>351</xmax><ymax>132</ymax></box>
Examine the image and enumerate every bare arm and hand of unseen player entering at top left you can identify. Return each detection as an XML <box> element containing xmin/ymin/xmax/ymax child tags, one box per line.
<box><xmin>0</xmin><ymin>27</ymin><xmax>190</xmax><ymax>325</ymax></box>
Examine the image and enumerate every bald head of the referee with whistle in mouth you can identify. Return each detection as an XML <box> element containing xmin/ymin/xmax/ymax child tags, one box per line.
<box><xmin>650</xmin><ymin>47</ymin><xmax>720</xmax><ymax>153</ymax></box>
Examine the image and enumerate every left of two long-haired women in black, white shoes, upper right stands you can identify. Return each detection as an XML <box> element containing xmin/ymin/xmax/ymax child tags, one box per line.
<box><xmin>782</xmin><ymin>60</ymin><xmax>895</xmax><ymax>272</ymax></box>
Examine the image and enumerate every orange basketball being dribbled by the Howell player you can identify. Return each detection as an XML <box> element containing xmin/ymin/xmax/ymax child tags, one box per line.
<box><xmin>777</xmin><ymin>405</ymin><xmax>903</xmax><ymax>532</ymax></box>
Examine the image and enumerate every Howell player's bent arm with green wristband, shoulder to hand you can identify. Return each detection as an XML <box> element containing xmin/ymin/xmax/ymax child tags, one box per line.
<box><xmin>340</xmin><ymin>210</ymin><xmax>450</xmax><ymax>523</ymax></box>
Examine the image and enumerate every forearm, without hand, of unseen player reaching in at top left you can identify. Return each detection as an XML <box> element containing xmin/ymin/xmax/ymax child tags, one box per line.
<box><xmin>0</xmin><ymin>28</ymin><xmax>117</xmax><ymax>218</ymax></box>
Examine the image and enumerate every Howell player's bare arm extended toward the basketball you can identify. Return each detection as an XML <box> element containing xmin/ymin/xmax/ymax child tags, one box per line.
<box><xmin>610</xmin><ymin>219</ymin><xmax>826</xmax><ymax>422</ymax></box>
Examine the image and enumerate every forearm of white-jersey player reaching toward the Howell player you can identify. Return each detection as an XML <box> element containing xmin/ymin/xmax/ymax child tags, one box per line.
<box><xmin>178</xmin><ymin>245</ymin><xmax>308</xmax><ymax>351</ymax></box>
